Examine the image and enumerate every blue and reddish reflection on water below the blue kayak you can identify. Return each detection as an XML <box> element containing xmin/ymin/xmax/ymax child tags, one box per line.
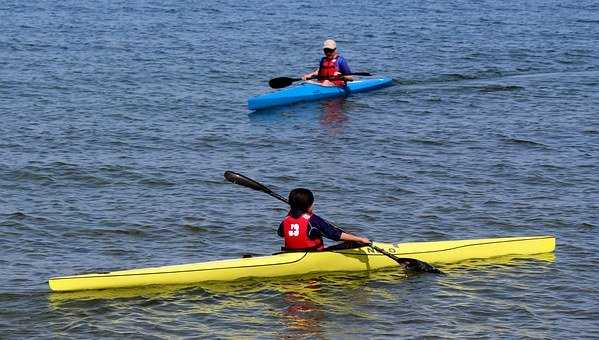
<box><xmin>248</xmin><ymin>98</ymin><xmax>349</xmax><ymax>133</ymax></box>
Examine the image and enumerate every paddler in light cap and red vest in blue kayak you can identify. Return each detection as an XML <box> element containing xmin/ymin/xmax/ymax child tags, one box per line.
<box><xmin>302</xmin><ymin>39</ymin><xmax>354</xmax><ymax>86</ymax></box>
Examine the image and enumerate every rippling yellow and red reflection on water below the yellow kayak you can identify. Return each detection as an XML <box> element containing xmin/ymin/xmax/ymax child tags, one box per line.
<box><xmin>48</xmin><ymin>254</ymin><xmax>555</xmax><ymax>339</ymax></box>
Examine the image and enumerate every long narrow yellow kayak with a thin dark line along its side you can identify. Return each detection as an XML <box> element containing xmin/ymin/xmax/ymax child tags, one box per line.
<box><xmin>48</xmin><ymin>236</ymin><xmax>555</xmax><ymax>292</ymax></box>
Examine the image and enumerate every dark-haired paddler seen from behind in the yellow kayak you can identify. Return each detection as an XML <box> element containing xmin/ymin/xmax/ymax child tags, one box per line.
<box><xmin>277</xmin><ymin>188</ymin><xmax>370</xmax><ymax>251</ymax></box>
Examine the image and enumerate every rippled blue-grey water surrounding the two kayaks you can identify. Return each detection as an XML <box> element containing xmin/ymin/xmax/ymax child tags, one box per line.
<box><xmin>0</xmin><ymin>1</ymin><xmax>599</xmax><ymax>338</ymax></box>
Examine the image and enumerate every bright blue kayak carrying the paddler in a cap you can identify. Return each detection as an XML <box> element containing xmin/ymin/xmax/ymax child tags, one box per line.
<box><xmin>248</xmin><ymin>78</ymin><xmax>393</xmax><ymax>110</ymax></box>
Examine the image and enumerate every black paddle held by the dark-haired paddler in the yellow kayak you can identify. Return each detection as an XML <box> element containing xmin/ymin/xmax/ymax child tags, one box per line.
<box><xmin>225</xmin><ymin>171</ymin><xmax>443</xmax><ymax>274</ymax></box>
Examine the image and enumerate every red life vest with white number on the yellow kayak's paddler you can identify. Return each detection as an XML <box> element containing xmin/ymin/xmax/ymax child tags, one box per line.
<box><xmin>283</xmin><ymin>213</ymin><xmax>324</xmax><ymax>250</ymax></box>
